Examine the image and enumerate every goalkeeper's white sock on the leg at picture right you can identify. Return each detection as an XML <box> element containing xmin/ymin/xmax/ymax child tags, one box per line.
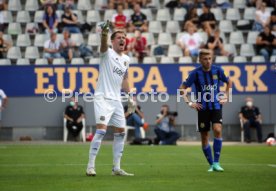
<box><xmin>113</xmin><ymin>133</ymin><xmax>125</xmax><ymax>170</ymax></box>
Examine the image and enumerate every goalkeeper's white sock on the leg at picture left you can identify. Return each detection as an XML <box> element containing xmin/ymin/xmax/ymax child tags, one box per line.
<box><xmin>87</xmin><ymin>129</ymin><xmax>106</xmax><ymax>169</ymax></box>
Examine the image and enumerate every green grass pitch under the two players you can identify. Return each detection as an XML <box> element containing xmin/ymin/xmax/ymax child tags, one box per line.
<box><xmin>0</xmin><ymin>143</ymin><xmax>276</xmax><ymax>191</ymax></box>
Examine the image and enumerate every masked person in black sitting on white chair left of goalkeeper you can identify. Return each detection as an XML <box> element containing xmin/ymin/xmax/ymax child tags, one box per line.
<box><xmin>64</xmin><ymin>97</ymin><xmax>84</xmax><ymax>140</ymax></box>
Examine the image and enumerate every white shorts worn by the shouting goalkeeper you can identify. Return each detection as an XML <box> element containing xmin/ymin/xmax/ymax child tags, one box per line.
<box><xmin>94</xmin><ymin>96</ymin><xmax>126</xmax><ymax>128</ymax></box>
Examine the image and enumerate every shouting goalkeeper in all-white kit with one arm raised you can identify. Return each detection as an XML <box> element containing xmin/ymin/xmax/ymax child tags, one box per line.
<box><xmin>86</xmin><ymin>21</ymin><xmax>135</xmax><ymax>176</ymax></box>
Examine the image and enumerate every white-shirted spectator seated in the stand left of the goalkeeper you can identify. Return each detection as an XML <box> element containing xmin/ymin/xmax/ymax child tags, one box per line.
<box><xmin>43</xmin><ymin>33</ymin><xmax>61</xmax><ymax>63</ymax></box>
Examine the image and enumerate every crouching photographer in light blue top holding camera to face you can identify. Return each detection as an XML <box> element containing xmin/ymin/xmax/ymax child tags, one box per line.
<box><xmin>154</xmin><ymin>105</ymin><xmax>180</xmax><ymax>145</ymax></box>
